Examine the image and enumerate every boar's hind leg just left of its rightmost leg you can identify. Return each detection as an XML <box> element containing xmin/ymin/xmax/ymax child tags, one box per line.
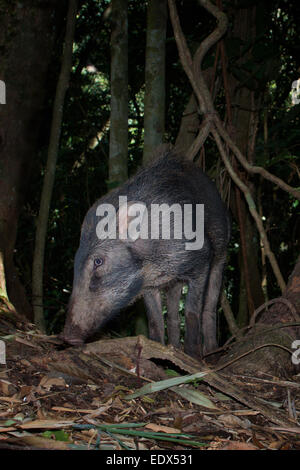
<box><xmin>184</xmin><ymin>262</ymin><xmax>210</xmax><ymax>358</ymax></box>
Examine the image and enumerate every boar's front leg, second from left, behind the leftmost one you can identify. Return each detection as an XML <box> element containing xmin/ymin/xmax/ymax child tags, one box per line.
<box><xmin>166</xmin><ymin>283</ymin><xmax>182</xmax><ymax>348</ymax></box>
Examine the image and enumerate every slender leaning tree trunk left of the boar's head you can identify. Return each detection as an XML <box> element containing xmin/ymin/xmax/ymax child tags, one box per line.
<box><xmin>32</xmin><ymin>0</ymin><xmax>77</xmax><ymax>332</ymax></box>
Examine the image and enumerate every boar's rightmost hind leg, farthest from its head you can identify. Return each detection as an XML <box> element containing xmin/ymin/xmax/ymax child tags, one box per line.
<box><xmin>202</xmin><ymin>255</ymin><xmax>226</xmax><ymax>354</ymax></box>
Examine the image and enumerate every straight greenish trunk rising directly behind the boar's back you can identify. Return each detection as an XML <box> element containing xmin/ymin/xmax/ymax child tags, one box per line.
<box><xmin>143</xmin><ymin>0</ymin><xmax>167</xmax><ymax>164</ymax></box>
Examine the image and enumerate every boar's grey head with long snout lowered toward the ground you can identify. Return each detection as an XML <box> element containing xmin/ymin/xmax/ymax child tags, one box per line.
<box><xmin>62</xmin><ymin>198</ymin><xmax>146</xmax><ymax>345</ymax></box>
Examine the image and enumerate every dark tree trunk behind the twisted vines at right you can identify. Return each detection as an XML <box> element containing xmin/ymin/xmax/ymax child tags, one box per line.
<box><xmin>228</xmin><ymin>3</ymin><xmax>264</xmax><ymax>326</ymax></box>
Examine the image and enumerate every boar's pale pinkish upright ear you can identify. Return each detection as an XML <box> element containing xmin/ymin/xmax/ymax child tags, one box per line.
<box><xmin>117</xmin><ymin>201</ymin><xmax>148</xmax><ymax>242</ymax></box>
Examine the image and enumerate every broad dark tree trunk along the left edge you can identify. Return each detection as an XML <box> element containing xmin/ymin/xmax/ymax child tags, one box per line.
<box><xmin>0</xmin><ymin>0</ymin><xmax>60</xmax><ymax>318</ymax></box>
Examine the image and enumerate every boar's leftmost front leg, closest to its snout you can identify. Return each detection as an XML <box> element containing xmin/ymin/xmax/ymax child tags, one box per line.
<box><xmin>143</xmin><ymin>289</ymin><xmax>165</xmax><ymax>344</ymax></box>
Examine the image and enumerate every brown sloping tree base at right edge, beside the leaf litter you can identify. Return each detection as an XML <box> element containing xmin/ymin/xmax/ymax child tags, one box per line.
<box><xmin>218</xmin><ymin>257</ymin><xmax>300</xmax><ymax>378</ymax></box>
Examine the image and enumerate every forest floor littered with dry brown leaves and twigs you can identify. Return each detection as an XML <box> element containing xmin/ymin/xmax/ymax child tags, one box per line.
<box><xmin>0</xmin><ymin>312</ymin><xmax>300</xmax><ymax>450</ymax></box>
